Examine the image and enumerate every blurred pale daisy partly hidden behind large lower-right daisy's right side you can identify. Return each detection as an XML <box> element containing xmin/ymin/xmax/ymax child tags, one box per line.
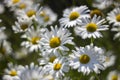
<box><xmin>103</xmin><ymin>51</ymin><xmax>116</xmax><ymax>68</ymax></box>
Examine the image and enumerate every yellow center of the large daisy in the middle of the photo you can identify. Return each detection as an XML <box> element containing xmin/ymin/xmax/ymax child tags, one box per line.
<box><xmin>49</xmin><ymin>37</ymin><xmax>61</xmax><ymax>48</ymax></box>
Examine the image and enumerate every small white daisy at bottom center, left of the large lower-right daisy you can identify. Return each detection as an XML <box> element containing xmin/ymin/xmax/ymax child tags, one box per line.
<box><xmin>45</xmin><ymin>57</ymin><xmax>69</xmax><ymax>79</ymax></box>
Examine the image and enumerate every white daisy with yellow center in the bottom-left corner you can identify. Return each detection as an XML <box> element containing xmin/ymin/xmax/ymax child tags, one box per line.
<box><xmin>3</xmin><ymin>63</ymin><xmax>24</xmax><ymax>80</ymax></box>
